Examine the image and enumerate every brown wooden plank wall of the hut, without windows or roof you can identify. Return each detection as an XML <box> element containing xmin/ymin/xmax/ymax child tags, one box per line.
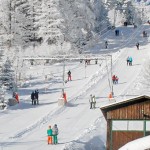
<box><xmin>106</xmin><ymin>101</ymin><xmax>150</xmax><ymax>150</ymax></box>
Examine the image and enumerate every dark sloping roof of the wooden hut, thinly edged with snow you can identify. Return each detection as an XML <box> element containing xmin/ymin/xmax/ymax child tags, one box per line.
<box><xmin>100</xmin><ymin>95</ymin><xmax>150</xmax><ymax>117</ymax></box>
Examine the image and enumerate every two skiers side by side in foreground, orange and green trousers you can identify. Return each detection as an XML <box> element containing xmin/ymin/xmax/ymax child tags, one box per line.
<box><xmin>47</xmin><ymin>124</ymin><xmax>58</xmax><ymax>144</ymax></box>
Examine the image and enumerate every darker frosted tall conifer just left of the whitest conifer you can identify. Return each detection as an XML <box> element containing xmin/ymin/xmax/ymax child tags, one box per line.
<box><xmin>14</xmin><ymin>0</ymin><xmax>34</xmax><ymax>48</ymax></box>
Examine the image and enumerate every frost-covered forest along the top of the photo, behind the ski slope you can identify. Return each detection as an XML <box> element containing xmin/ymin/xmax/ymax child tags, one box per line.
<box><xmin>0</xmin><ymin>0</ymin><xmax>145</xmax><ymax>54</ymax></box>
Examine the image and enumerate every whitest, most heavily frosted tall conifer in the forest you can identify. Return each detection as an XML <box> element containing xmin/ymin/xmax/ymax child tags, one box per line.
<box><xmin>39</xmin><ymin>0</ymin><xmax>63</xmax><ymax>45</ymax></box>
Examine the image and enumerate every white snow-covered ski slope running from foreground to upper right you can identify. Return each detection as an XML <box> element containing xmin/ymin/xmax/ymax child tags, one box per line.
<box><xmin>0</xmin><ymin>25</ymin><xmax>150</xmax><ymax>150</ymax></box>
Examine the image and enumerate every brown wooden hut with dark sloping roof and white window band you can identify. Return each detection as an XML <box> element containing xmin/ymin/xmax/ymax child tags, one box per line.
<box><xmin>100</xmin><ymin>95</ymin><xmax>150</xmax><ymax>150</ymax></box>
